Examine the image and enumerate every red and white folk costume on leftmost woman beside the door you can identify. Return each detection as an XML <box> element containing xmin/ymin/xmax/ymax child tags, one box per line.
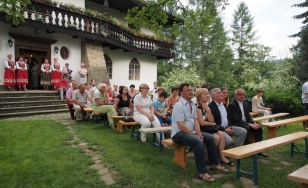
<box><xmin>4</xmin><ymin>59</ymin><xmax>16</xmax><ymax>86</ymax></box>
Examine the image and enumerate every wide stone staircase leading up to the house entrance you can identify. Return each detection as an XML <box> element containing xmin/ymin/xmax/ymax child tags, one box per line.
<box><xmin>0</xmin><ymin>90</ymin><xmax>69</xmax><ymax>119</ymax></box>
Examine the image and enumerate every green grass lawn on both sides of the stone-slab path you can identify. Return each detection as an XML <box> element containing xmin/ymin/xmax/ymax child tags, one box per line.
<box><xmin>0</xmin><ymin>121</ymin><xmax>308</xmax><ymax>188</ymax></box>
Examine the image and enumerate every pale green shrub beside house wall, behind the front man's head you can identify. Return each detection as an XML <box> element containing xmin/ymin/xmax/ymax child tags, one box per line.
<box><xmin>160</xmin><ymin>66</ymin><xmax>201</xmax><ymax>93</ymax></box>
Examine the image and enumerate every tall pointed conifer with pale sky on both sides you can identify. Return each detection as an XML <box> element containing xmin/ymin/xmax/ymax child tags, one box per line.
<box><xmin>231</xmin><ymin>2</ymin><xmax>256</xmax><ymax>75</ymax></box>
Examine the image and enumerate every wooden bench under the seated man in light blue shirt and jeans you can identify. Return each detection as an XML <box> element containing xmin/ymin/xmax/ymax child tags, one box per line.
<box><xmin>162</xmin><ymin>139</ymin><xmax>186</xmax><ymax>168</ymax></box>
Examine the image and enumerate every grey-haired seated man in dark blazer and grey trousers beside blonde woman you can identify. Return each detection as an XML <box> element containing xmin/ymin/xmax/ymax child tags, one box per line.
<box><xmin>209</xmin><ymin>88</ymin><xmax>247</xmax><ymax>148</ymax></box>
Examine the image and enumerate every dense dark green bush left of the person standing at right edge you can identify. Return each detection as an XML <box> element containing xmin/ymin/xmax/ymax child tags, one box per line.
<box><xmin>263</xmin><ymin>87</ymin><xmax>304</xmax><ymax>117</ymax></box>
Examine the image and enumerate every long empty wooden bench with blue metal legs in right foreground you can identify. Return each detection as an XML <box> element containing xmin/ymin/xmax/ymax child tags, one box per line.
<box><xmin>222</xmin><ymin>132</ymin><xmax>308</xmax><ymax>185</ymax></box>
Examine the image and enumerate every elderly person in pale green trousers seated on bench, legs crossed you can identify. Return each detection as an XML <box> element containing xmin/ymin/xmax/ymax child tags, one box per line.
<box><xmin>93</xmin><ymin>83</ymin><xmax>117</xmax><ymax>129</ymax></box>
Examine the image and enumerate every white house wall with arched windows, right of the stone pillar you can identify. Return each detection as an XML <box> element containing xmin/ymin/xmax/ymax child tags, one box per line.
<box><xmin>104</xmin><ymin>48</ymin><xmax>157</xmax><ymax>90</ymax></box>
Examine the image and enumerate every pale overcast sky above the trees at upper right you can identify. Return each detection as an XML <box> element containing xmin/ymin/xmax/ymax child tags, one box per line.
<box><xmin>221</xmin><ymin>0</ymin><xmax>307</xmax><ymax>59</ymax></box>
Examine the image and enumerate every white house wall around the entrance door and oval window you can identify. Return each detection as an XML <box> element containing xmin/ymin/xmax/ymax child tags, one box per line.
<box><xmin>0</xmin><ymin>22</ymin><xmax>81</xmax><ymax>85</ymax></box>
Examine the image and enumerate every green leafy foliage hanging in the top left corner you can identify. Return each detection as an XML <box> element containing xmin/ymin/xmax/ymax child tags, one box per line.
<box><xmin>0</xmin><ymin>0</ymin><xmax>31</xmax><ymax>26</ymax></box>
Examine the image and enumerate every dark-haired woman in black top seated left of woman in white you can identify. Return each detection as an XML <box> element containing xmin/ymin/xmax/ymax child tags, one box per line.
<box><xmin>114</xmin><ymin>86</ymin><xmax>133</xmax><ymax>116</ymax></box>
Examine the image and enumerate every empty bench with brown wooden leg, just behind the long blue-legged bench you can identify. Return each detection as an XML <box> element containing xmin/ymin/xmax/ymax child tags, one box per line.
<box><xmin>261</xmin><ymin>115</ymin><xmax>308</xmax><ymax>139</ymax></box>
